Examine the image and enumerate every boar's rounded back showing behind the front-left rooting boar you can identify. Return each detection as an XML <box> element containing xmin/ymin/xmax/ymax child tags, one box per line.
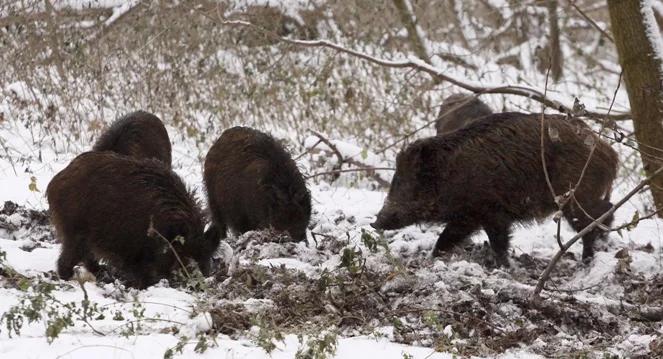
<box><xmin>92</xmin><ymin>111</ymin><xmax>171</xmax><ymax>167</ymax></box>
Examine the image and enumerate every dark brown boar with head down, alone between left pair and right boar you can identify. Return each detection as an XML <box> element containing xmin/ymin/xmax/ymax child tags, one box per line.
<box><xmin>204</xmin><ymin>127</ymin><xmax>311</xmax><ymax>241</ymax></box>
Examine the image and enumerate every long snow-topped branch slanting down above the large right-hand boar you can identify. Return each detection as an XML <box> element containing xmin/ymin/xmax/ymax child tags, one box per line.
<box><xmin>221</xmin><ymin>20</ymin><xmax>631</xmax><ymax>121</ymax></box>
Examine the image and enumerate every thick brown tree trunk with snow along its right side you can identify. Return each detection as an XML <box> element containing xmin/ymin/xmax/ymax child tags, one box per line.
<box><xmin>608</xmin><ymin>0</ymin><xmax>663</xmax><ymax>217</ymax></box>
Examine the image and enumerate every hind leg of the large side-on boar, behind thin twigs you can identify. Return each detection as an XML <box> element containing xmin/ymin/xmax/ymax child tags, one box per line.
<box><xmin>564</xmin><ymin>198</ymin><xmax>614</xmax><ymax>262</ymax></box>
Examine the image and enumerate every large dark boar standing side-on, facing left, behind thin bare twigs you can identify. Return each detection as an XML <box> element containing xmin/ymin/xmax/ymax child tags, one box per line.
<box><xmin>372</xmin><ymin>112</ymin><xmax>618</xmax><ymax>265</ymax></box>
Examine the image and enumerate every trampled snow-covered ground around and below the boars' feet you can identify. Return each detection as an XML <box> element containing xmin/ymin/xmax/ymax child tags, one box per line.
<box><xmin>0</xmin><ymin>121</ymin><xmax>663</xmax><ymax>358</ymax></box>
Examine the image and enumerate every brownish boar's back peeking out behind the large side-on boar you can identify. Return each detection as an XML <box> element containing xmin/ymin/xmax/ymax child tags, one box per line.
<box><xmin>435</xmin><ymin>93</ymin><xmax>493</xmax><ymax>136</ymax></box>
